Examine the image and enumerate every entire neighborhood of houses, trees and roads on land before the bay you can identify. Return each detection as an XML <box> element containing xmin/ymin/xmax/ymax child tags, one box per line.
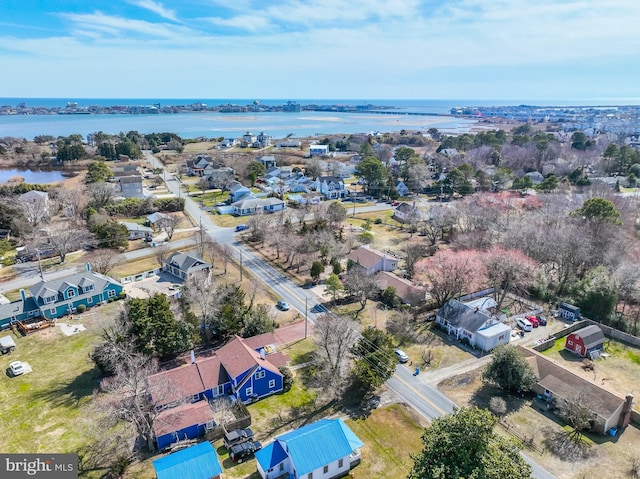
<box><xmin>0</xmin><ymin>112</ymin><xmax>640</xmax><ymax>479</ymax></box>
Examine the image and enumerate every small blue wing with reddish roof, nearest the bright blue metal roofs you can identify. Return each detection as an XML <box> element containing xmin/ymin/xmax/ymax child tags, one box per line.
<box><xmin>153</xmin><ymin>401</ymin><xmax>216</xmax><ymax>450</ymax></box>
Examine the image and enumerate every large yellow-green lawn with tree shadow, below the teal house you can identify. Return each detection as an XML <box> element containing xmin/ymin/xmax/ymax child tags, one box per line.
<box><xmin>0</xmin><ymin>303</ymin><xmax>120</xmax><ymax>453</ymax></box>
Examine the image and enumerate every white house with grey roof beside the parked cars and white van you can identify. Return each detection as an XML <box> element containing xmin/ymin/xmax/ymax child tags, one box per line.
<box><xmin>436</xmin><ymin>298</ymin><xmax>511</xmax><ymax>351</ymax></box>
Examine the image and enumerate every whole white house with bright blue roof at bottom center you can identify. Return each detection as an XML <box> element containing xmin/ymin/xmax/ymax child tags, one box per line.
<box><xmin>255</xmin><ymin>419</ymin><xmax>364</xmax><ymax>479</ymax></box>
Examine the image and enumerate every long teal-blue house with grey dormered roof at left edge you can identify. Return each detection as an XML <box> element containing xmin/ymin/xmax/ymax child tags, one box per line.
<box><xmin>0</xmin><ymin>263</ymin><xmax>122</xmax><ymax>328</ymax></box>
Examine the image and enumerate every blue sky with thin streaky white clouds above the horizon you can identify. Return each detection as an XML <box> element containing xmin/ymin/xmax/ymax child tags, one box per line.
<box><xmin>0</xmin><ymin>0</ymin><xmax>640</xmax><ymax>100</ymax></box>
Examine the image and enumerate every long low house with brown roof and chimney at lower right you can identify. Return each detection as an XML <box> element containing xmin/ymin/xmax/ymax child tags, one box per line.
<box><xmin>517</xmin><ymin>345</ymin><xmax>633</xmax><ymax>434</ymax></box>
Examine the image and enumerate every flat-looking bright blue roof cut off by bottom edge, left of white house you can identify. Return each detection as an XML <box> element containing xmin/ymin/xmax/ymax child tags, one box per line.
<box><xmin>153</xmin><ymin>442</ymin><xmax>222</xmax><ymax>479</ymax></box>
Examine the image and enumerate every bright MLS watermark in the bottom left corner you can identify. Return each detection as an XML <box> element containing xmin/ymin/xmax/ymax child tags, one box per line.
<box><xmin>0</xmin><ymin>454</ymin><xmax>78</xmax><ymax>479</ymax></box>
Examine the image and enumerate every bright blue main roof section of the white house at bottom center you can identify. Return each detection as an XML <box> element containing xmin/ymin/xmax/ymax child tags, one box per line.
<box><xmin>276</xmin><ymin>419</ymin><xmax>363</xmax><ymax>476</ymax></box>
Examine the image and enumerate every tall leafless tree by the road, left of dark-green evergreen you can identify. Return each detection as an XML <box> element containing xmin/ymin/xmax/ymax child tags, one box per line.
<box><xmin>314</xmin><ymin>313</ymin><xmax>358</xmax><ymax>396</ymax></box>
